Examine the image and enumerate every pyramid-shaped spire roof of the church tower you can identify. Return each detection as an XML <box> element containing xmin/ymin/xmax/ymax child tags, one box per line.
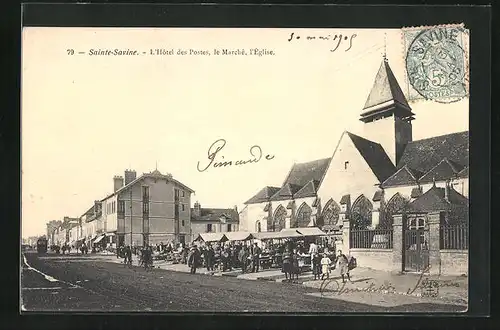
<box><xmin>362</xmin><ymin>59</ymin><xmax>412</xmax><ymax>116</ymax></box>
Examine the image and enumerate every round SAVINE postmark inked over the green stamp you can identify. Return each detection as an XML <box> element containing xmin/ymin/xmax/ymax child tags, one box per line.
<box><xmin>406</xmin><ymin>27</ymin><xmax>467</xmax><ymax>103</ymax></box>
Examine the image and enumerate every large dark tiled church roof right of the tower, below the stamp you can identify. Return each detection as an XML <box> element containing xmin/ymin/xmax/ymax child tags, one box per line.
<box><xmin>398</xmin><ymin>131</ymin><xmax>469</xmax><ymax>173</ymax></box>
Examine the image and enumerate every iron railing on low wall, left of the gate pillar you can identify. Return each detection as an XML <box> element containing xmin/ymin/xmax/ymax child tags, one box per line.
<box><xmin>349</xmin><ymin>229</ymin><xmax>393</xmax><ymax>249</ymax></box>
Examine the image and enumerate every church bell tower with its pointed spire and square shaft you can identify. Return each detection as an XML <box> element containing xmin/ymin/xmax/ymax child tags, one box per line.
<box><xmin>359</xmin><ymin>56</ymin><xmax>415</xmax><ymax>166</ymax></box>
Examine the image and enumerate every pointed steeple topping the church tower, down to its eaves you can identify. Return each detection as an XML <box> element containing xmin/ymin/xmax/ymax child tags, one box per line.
<box><xmin>360</xmin><ymin>54</ymin><xmax>414</xmax><ymax>122</ymax></box>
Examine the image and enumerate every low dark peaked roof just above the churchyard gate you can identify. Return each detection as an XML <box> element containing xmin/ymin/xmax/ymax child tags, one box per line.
<box><xmin>409</xmin><ymin>186</ymin><xmax>468</xmax><ymax>213</ymax></box>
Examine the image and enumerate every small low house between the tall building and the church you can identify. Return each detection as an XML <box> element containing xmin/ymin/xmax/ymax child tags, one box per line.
<box><xmin>191</xmin><ymin>202</ymin><xmax>240</xmax><ymax>241</ymax></box>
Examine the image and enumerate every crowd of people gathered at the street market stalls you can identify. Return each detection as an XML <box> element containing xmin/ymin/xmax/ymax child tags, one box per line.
<box><xmin>113</xmin><ymin>240</ymin><xmax>356</xmax><ymax>282</ymax></box>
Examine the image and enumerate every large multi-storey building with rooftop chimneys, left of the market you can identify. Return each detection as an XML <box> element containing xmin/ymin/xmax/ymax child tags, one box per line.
<box><xmin>82</xmin><ymin>170</ymin><xmax>194</xmax><ymax>247</ymax></box>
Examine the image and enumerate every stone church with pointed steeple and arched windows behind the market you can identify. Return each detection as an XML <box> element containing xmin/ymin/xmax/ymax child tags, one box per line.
<box><xmin>240</xmin><ymin>57</ymin><xmax>469</xmax><ymax>274</ymax></box>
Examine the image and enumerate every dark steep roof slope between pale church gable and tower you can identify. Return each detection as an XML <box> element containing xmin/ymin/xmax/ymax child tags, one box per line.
<box><xmin>347</xmin><ymin>132</ymin><xmax>395</xmax><ymax>182</ymax></box>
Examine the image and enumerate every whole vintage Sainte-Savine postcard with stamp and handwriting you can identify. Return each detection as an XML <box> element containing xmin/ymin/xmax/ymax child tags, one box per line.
<box><xmin>20</xmin><ymin>22</ymin><xmax>470</xmax><ymax>313</ymax></box>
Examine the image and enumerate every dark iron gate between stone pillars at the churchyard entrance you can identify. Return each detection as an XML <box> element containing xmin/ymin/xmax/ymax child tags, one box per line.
<box><xmin>403</xmin><ymin>228</ymin><xmax>429</xmax><ymax>272</ymax></box>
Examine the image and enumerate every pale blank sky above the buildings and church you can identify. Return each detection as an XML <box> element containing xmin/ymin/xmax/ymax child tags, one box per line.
<box><xmin>21</xmin><ymin>27</ymin><xmax>469</xmax><ymax>237</ymax></box>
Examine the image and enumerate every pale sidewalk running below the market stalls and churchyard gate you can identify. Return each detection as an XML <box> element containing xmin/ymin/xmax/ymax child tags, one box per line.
<box><xmin>88</xmin><ymin>255</ymin><xmax>468</xmax><ymax>306</ymax></box>
